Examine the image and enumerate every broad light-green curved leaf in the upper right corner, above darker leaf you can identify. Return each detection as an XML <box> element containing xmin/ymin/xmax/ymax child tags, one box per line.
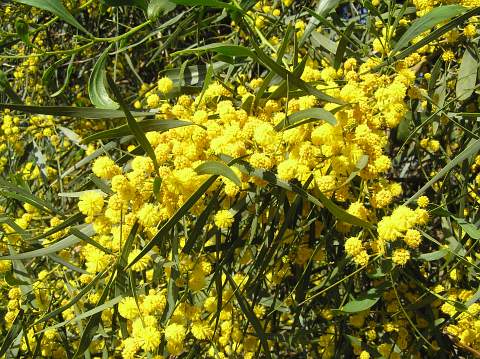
<box><xmin>392</xmin><ymin>5</ymin><xmax>467</xmax><ymax>53</ymax></box>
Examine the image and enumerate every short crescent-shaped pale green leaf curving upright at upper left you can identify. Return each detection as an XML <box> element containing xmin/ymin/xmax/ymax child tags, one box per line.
<box><xmin>88</xmin><ymin>45</ymin><xmax>119</xmax><ymax>110</ymax></box>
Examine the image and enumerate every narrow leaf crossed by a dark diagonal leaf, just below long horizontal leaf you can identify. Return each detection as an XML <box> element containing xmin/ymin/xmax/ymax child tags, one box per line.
<box><xmin>83</xmin><ymin>120</ymin><xmax>195</xmax><ymax>143</ymax></box>
